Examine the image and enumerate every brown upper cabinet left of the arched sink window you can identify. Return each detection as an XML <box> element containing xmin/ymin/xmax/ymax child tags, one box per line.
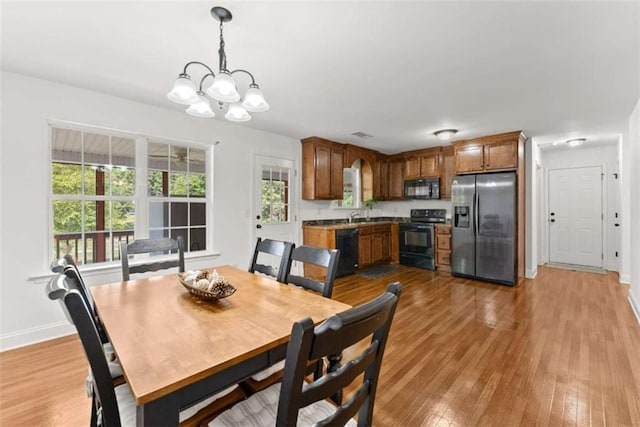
<box><xmin>301</xmin><ymin>137</ymin><xmax>344</xmax><ymax>200</ymax></box>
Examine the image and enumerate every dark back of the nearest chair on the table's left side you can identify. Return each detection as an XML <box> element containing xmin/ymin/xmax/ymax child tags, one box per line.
<box><xmin>48</xmin><ymin>274</ymin><xmax>121</xmax><ymax>426</ymax></box>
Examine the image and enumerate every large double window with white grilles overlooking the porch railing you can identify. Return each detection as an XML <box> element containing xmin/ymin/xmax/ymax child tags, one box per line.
<box><xmin>51</xmin><ymin>126</ymin><xmax>207</xmax><ymax>264</ymax></box>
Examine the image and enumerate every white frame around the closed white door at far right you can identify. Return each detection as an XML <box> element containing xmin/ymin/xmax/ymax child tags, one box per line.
<box><xmin>541</xmin><ymin>166</ymin><xmax>609</xmax><ymax>270</ymax></box>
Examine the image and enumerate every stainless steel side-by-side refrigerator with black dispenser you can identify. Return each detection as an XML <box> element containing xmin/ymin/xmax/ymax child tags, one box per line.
<box><xmin>451</xmin><ymin>172</ymin><xmax>517</xmax><ymax>285</ymax></box>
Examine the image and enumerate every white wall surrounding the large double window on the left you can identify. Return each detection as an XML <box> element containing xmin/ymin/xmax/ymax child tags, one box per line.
<box><xmin>0</xmin><ymin>73</ymin><xmax>300</xmax><ymax>350</ymax></box>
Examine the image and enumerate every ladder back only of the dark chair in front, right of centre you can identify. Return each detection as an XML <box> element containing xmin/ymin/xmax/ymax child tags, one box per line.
<box><xmin>276</xmin><ymin>283</ymin><xmax>402</xmax><ymax>427</ymax></box>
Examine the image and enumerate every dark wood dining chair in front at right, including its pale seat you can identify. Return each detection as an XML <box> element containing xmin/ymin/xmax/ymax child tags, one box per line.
<box><xmin>209</xmin><ymin>282</ymin><xmax>402</xmax><ymax>427</ymax></box>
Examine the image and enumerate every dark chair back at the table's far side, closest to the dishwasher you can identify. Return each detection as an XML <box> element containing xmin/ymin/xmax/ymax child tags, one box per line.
<box><xmin>285</xmin><ymin>245</ymin><xmax>340</xmax><ymax>298</ymax></box>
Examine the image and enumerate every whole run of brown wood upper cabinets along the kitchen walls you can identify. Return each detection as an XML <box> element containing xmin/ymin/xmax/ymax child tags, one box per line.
<box><xmin>301</xmin><ymin>131</ymin><xmax>525</xmax><ymax>201</ymax></box>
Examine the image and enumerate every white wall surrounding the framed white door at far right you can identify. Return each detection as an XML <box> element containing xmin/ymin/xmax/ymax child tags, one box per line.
<box><xmin>539</xmin><ymin>144</ymin><xmax>621</xmax><ymax>271</ymax></box>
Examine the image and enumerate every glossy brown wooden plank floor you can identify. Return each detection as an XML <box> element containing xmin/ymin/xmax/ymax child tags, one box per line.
<box><xmin>0</xmin><ymin>267</ymin><xmax>640</xmax><ymax>427</ymax></box>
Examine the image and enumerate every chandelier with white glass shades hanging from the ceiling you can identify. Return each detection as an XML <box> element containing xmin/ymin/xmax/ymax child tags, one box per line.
<box><xmin>167</xmin><ymin>7</ymin><xmax>269</xmax><ymax>122</ymax></box>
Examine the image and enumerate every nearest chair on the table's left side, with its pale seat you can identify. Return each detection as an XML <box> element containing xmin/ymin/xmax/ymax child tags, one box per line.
<box><xmin>52</xmin><ymin>274</ymin><xmax>245</xmax><ymax>427</ymax></box>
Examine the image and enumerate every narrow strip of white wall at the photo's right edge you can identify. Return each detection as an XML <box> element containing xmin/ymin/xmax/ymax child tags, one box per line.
<box><xmin>623</xmin><ymin>99</ymin><xmax>640</xmax><ymax>322</ymax></box>
